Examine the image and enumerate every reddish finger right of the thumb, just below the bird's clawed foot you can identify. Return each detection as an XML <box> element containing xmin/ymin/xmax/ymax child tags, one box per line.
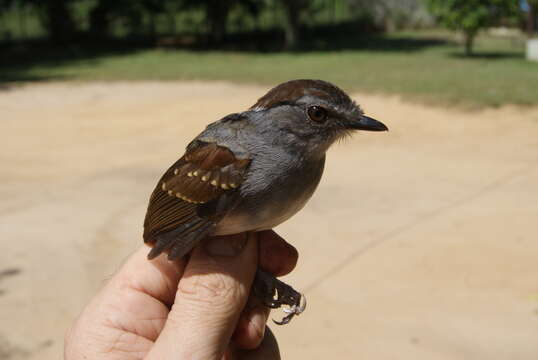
<box><xmin>232</xmin><ymin>294</ymin><xmax>270</xmax><ymax>349</ymax></box>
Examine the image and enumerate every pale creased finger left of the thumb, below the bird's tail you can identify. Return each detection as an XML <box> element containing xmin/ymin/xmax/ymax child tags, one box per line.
<box><xmin>65</xmin><ymin>246</ymin><xmax>184</xmax><ymax>358</ymax></box>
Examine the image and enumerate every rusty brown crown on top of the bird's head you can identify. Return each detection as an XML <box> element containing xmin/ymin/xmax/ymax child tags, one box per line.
<box><xmin>250</xmin><ymin>79</ymin><xmax>356</xmax><ymax>110</ymax></box>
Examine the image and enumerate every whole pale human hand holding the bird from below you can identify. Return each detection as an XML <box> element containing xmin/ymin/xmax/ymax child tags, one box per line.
<box><xmin>65</xmin><ymin>231</ymin><xmax>298</xmax><ymax>360</ymax></box>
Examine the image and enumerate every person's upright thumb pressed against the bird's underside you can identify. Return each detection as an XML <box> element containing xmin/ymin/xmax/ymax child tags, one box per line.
<box><xmin>148</xmin><ymin>233</ymin><xmax>258</xmax><ymax>360</ymax></box>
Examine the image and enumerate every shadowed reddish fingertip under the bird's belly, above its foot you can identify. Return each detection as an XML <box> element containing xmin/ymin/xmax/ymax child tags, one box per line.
<box><xmin>258</xmin><ymin>230</ymin><xmax>299</xmax><ymax>276</ymax></box>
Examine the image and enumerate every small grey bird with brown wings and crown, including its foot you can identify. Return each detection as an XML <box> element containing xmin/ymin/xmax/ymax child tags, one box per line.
<box><xmin>144</xmin><ymin>80</ymin><xmax>388</xmax><ymax>324</ymax></box>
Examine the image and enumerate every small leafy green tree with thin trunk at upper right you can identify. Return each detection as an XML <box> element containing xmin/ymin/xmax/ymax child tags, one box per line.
<box><xmin>426</xmin><ymin>0</ymin><xmax>519</xmax><ymax>56</ymax></box>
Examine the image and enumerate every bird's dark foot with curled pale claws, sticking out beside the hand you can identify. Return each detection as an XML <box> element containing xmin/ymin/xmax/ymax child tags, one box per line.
<box><xmin>252</xmin><ymin>269</ymin><xmax>306</xmax><ymax>325</ymax></box>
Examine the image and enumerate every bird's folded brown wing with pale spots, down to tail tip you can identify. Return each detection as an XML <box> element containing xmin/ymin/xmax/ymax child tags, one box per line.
<box><xmin>144</xmin><ymin>141</ymin><xmax>250</xmax><ymax>259</ymax></box>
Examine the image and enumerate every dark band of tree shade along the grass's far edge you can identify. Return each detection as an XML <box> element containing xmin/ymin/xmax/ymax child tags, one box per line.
<box><xmin>0</xmin><ymin>23</ymin><xmax>447</xmax><ymax>86</ymax></box>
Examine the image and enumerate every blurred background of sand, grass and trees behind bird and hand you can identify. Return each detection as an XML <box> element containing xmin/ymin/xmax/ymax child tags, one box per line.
<box><xmin>0</xmin><ymin>0</ymin><xmax>538</xmax><ymax>360</ymax></box>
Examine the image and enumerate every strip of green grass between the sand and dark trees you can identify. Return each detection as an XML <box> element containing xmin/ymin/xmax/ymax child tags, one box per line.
<box><xmin>0</xmin><ymin>32</ymin><xmax>538</xmax><ymax>107</ymax></box>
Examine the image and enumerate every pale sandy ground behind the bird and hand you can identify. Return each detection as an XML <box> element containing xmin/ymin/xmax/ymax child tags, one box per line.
<box><xmin>0</xmin><ymin>83</ymin><xmax>538</xmax><ymax>360</ymax></box>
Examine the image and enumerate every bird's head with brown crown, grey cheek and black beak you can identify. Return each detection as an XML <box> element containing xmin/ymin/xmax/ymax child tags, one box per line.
<box><xmin>250</xmin><ymin>80</ymin><xmax>388</xmax><ymax>153</ymax></box>
